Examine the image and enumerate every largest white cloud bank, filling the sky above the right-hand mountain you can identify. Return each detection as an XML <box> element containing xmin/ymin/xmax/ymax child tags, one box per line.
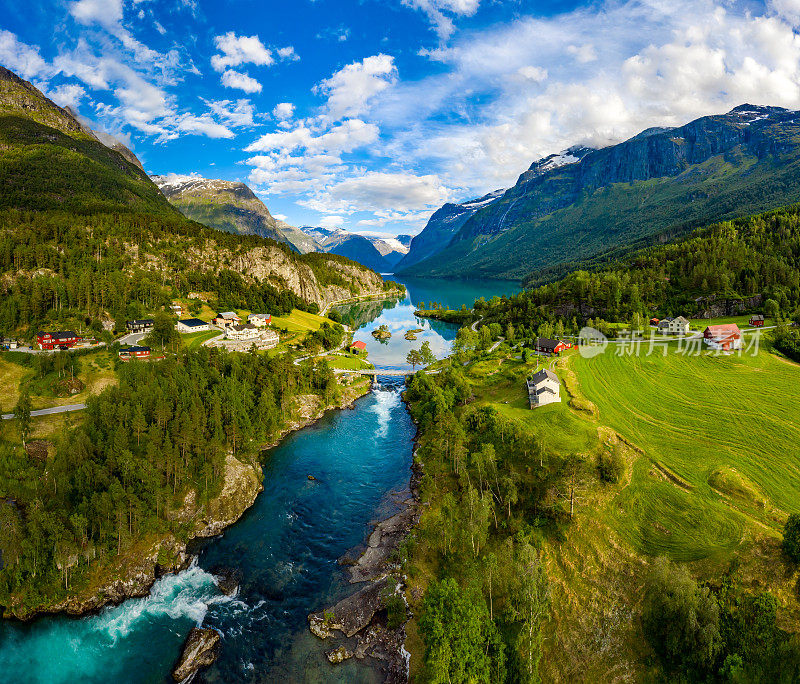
<box><xmin>371</xmin><ymin>0</ymin><xmax>800</xmax><ymax>192</ymax></box>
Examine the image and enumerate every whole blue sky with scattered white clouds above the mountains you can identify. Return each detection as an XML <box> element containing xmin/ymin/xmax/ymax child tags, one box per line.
<box><xmin>0</xmin><ymin>0</ymin><xmax>800</xmax><ymax>235</ymax></box>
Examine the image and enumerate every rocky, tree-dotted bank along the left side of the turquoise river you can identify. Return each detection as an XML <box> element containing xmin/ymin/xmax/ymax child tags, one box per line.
<box><xmin>0</xmin><ymin>382</ymin><xmax>370</xmax><ymax>623</ymax></box>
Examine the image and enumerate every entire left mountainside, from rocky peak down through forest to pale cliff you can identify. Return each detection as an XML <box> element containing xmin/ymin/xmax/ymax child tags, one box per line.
<box><xmin>0</xmin><ymin>69</ymin><xmax>384</xmax><ymax>320</ymax></box>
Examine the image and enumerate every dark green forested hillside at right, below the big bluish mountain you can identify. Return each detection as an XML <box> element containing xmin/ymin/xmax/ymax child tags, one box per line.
<box><xmin>476</xmin><ymin>207</ymin><xmax>800</xmax><ymax>336</ymax></box>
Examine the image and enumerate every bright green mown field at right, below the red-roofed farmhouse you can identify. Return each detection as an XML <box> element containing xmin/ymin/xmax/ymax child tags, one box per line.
<box><xmin>573</xmin><ymin>351</ymin><xmax>800</xmax><ymax>560</ymax></box>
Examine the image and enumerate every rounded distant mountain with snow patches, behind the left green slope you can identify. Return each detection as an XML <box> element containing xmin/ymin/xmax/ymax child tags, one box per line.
<box><xmin>152</xmin><ymin>174</ymin><xmax>308</xmax><ymax>251</ymax></box>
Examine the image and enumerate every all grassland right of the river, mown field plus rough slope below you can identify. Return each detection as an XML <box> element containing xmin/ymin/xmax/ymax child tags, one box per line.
<box><xmin>418</xmin><ymin>344</ymin><xmax>800</xmax><ymax>682</ymax></box>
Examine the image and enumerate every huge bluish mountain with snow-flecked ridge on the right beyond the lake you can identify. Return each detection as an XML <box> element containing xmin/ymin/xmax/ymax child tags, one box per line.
<box><xmin>400</xmin><ymin>105</ymin><xmax>800</xmax><ymax>279</ymax></box>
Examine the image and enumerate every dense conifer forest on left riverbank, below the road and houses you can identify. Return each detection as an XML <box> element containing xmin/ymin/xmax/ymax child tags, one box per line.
<box><xmin>0</xmin><ymin>348</ymin><xmax>338</xmax><ymax>606</ymax></box>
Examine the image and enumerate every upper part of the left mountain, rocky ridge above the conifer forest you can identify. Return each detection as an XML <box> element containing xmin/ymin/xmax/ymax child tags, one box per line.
<box><xmin>0</xmin><ymin>67</ymin><xmax>177</xmax><ymax>216</ymax></box>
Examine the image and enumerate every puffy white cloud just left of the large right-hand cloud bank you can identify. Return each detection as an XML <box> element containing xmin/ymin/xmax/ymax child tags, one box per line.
<box><xmin>314</xmin><ymin>54</ymin><xmax>397</xmax><ymax>119</ymax></box>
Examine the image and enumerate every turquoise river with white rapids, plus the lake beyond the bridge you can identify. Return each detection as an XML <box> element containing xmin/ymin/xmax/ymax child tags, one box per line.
<box><xmin>0</xmin><ymin>279</ymin><xmax>519</xmax><ymax>684</ymax></box>
